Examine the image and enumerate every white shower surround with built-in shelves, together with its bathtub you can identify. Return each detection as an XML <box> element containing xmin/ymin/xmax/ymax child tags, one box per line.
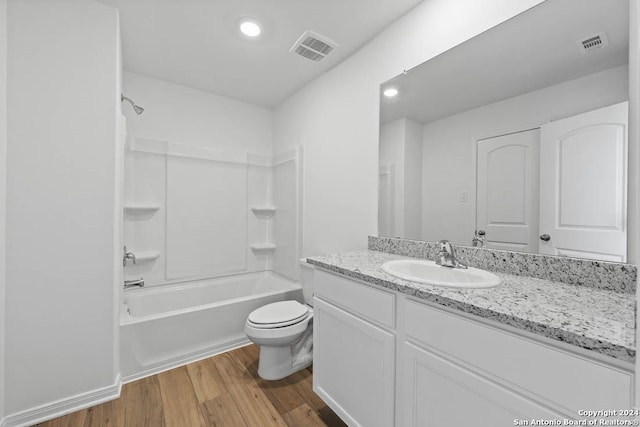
<box><xmin>120</xmin><ymin>136</ymin><xmax>302</xmax><ymax>382</ymax></box>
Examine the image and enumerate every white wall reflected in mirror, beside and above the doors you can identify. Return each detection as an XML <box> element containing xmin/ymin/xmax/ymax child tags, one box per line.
<box><xmin>421</xmin><ymin>66</ymin><xmax>628</xmax><ymax>245</ymax></box>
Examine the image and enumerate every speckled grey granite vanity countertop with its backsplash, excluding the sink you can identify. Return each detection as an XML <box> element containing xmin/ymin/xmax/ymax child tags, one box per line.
<box><xmin>308</xmin><ymin>237</ymin><xmax>636</xmax><ymax>362</ymax></box>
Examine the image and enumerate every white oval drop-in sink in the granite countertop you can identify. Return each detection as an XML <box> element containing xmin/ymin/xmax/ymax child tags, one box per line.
<box><xmin>382</xmin><ymin>259</ymin><xmax>502</xmax><ymax>289</ymax></box>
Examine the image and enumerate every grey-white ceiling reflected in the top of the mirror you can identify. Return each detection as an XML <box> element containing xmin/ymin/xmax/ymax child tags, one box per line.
<box><xmin>380</xmin><ymin>0</ymin><xmax>629</xmax><ymax>123</ymax></box>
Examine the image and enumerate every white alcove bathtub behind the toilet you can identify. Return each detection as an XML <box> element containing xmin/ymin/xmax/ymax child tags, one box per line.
<box><xmin>120</xmin><ymin>272</ymin><xmax>303</xmax><ymax>382</ymax></box>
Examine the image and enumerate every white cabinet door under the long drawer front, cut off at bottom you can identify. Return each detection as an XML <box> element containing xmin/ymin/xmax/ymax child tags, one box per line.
<box><xmin>402</xmin><ymin>343</ymin><xmax>563</xmax><ymax>427</ymax></box>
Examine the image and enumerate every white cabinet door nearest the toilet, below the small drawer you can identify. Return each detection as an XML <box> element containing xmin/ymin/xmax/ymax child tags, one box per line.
<box><xmin>313</xmin><ymin>298</ymin><xmax>395</xmax><ymax>427</ymax></box>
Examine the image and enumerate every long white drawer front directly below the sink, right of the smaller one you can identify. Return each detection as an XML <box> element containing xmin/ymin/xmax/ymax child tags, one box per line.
<box><xmin>405</xmin><ymin>299</ymin><xmax>633</xmax><ymax>416</ymax></box>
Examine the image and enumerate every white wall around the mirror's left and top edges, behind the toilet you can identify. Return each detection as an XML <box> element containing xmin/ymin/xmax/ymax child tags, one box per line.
<box><xmin>274</xmin><ymin>0</ymin><xmax>541</xmax><ymax>255</ymax></box>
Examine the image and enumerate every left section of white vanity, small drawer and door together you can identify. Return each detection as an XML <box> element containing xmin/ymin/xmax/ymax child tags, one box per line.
<box><xmin>313</xmin><ymin>271</ymin><xmax>396</xmax><ymax>427</ymax></box>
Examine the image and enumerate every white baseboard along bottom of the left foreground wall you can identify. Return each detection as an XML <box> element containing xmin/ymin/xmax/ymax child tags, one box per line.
<box><xmin>0</xmin><ymin>374</ymin><xmax>122</xmax><ymax>427</ymax></box>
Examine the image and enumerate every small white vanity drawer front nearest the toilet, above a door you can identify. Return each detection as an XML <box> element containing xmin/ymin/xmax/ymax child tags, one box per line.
<box><xmin>313</xmin><ymin>270</ymin><xmax>396</xmax><ymax>328</ymax></box>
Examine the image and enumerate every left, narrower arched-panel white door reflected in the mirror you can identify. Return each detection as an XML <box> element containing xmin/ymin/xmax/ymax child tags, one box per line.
<box><xmin>476</xmin><ymin>129</ymin><xmax>540</xmax><ymax>252</ymax></box>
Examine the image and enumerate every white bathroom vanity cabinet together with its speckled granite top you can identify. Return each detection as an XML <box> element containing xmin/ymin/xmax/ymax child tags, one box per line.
<box><xmin>308</xmin><ymin>242</ymin><xmax>635</xmax><ymax>427</ymax></box>
